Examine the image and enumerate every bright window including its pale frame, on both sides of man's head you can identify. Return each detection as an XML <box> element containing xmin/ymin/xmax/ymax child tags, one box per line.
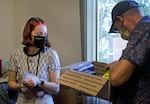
<box><xmin>81</xmin><ymin>0</ymin><xmax>150</xmax><ymax>63</ymax></box>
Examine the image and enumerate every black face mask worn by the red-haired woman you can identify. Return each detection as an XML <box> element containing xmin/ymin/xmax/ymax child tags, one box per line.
<box><xmin>34</xmin><ymin>36</ymin><xmax>47</xmax><ymax>48</ymax></box>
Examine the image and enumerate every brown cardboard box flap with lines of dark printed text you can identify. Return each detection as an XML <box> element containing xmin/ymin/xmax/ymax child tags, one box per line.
<box><xmin>59</xmin><ymin>69</ymin><xmax>107</xmax><ymax>96</ymax></box>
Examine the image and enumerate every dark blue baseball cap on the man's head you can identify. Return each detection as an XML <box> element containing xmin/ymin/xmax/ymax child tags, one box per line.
<box><xmin>109</xmin><ymin>0</ymin><xmax>139</xmax><ymax>33</ymax></box>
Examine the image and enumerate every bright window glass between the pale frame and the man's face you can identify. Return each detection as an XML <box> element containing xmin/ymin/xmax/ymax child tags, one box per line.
<box><xmin>96</xmin><ymin>0</ymin><xmax>126</xmax><ymax>63</ymax></box>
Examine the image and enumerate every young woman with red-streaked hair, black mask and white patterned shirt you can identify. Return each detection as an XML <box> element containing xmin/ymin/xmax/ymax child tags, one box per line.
<box><xmin>8</xmin><ymin>17</ymin><xmax>60</xmax><ymax>104</ymax></box>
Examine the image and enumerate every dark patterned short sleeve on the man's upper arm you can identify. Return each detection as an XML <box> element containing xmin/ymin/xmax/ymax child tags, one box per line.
<box><xmin>121</xmin><ymin>20</ymin><xmax>150</xmax><ymax>65</ymax></box>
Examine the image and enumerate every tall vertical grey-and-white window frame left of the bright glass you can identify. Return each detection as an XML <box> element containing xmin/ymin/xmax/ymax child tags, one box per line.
<box><xmin>80</xmin><ymin>0</ymin><xmax>97</xmax><ymax>61</ymax></box>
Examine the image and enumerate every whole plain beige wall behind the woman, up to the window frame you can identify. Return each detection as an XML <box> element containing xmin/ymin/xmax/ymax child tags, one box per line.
<box><xmin>0</xmin><ymin>0</ymin><xmax>81</xmax><ymax>66</ymax></box>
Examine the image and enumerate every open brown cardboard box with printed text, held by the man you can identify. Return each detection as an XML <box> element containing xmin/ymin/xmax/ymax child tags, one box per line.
<box><xmin>59</xmin><ymin>62</ymin><xmax>112</xmax><ymax>101</ymax></box>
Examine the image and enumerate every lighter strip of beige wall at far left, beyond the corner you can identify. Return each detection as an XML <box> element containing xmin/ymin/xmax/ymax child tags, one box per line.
<box><xmin>0</xmin><ymin>0</ymin><xmax>15</xmax><ymax>60</ymax></box>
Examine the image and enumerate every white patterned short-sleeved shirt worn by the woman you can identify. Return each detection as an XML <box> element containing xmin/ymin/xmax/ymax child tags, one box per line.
<box><xmin>9</xmin><ymin>47</ymin><xmax>60</xmax><ymax>104</ymax></box>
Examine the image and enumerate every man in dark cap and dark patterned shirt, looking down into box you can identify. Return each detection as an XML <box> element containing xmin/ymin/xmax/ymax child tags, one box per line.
<box><xmin>106</xmin><ymin>0</ymin><xmax>150</xmax><ymax>104</ymax></box>
